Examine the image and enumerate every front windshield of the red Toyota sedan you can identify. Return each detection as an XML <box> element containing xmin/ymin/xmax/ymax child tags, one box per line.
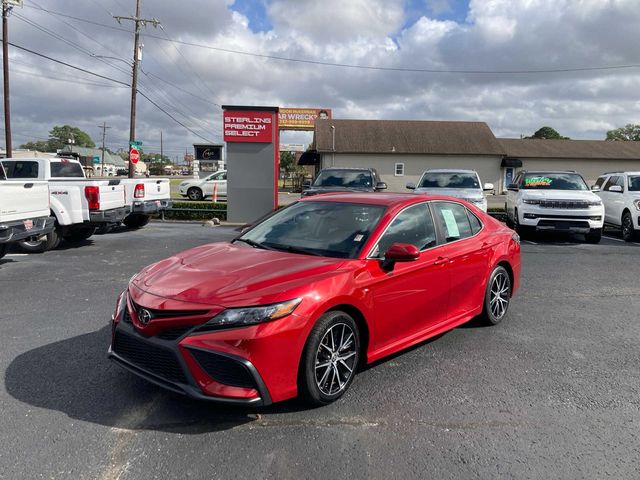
<box><xmin>235</xmin><ymin>202</ymin><xmax>385</xmax><ymax>258</ymax></box>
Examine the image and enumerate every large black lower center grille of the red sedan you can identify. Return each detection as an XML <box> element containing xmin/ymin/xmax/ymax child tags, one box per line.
<box><xmin>113</xmin><ymin>330</ymin><xmax>187</xmax><ymax>383</ymax></box>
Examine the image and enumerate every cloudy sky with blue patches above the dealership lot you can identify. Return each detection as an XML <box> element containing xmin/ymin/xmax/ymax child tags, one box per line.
<box><xmin>2</xmin><ymin>0</ymin><xmax>640</xmax><ymax>157</ymax></box>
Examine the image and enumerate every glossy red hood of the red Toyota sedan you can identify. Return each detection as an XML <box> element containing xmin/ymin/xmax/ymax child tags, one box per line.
<box><xmin>132</xmin><ymin>242</ymin><xmax>345</xmax><ymax>307</ymax></box>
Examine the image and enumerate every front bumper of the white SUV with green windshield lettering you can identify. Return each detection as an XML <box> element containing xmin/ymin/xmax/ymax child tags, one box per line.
<box><xmin>518</xmin><ymin>205</ymin><xmax>604</xmax><ymax>234</ymax></box>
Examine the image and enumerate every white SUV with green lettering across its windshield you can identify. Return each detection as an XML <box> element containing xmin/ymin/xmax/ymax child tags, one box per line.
<box><xmin>505</xmin><ymin>171</ymin><xmax>604</xmax><ymax>243</ymax></box>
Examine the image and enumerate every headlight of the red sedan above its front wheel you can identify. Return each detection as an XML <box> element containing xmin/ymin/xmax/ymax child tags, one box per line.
<box><xmin>194</xmin><ymin>298</ymin><xmax>302</xmax><ymax>333</ymax></box>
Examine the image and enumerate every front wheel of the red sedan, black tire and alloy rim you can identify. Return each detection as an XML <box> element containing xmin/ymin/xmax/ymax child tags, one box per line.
<box><xmin>298</xmin><ymin>311</ymin><xmax>360</xmax><ymax>406</ymax></box>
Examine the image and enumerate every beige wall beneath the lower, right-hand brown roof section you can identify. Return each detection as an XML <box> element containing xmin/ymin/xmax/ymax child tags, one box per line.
<box><xmin>517</xmin><ymin>158</ymin><xmax>640</xmax><ymax>186</ymax></box>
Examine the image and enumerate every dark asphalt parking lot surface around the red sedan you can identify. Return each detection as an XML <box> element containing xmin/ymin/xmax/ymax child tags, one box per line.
<box><xmin>0</xmin><ymin>223</ymin><xmax>640</xmax><ymax>479</ymax></box>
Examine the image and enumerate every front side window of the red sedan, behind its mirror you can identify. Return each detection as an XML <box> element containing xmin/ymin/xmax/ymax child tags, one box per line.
<box><xmin>371</xmin><ymin>203</ymin><xmax>437</xmax><ymax>258</ymax></box>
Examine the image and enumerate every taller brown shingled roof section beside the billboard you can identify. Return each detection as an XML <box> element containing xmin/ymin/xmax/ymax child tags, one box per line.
<box><xmin>314</xmin><ymin>120</ymin><xmax>504</xmax><ymax>155</ymax></box>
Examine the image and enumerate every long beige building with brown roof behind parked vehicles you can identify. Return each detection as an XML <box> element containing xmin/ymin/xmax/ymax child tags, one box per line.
<box><xmin>299</xmin><ymin>119</ymin><xmax>640</xmax><ymax>192</ymax></box>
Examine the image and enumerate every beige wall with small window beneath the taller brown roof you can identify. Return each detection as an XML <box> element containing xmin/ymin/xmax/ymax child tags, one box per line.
<box><xmin>321</xmin><ymin>153</ymin><xmax>503</xmax><ymax>192</ymax></box>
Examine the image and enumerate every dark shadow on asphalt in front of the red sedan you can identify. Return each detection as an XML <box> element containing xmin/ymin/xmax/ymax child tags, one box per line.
<box><xmin>5</xmin><ymin>326</ymin><xmax>302</xmax><ymax>434</ymax></box>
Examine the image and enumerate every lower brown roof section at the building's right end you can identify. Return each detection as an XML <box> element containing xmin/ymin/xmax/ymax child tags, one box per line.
<box><xmin>498</xmin><ymin>138</ymin><xmax>640</xmax><ymax>160</ymax></box>
